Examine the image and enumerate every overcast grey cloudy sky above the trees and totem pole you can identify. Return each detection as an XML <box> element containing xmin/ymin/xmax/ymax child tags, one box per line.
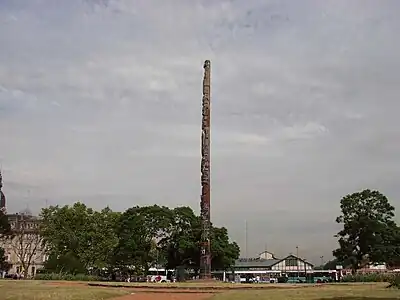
<box><xmin>0</xmin><ymin>0</ymin><xmax>400</xmax><ymax>262</ymax></box>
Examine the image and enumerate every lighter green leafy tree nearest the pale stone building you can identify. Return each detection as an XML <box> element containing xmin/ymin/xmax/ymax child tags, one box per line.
<box><xmin>40</xmin><ymin>202</ymin><xmax>119</xmax><ymax>272</ymax></box>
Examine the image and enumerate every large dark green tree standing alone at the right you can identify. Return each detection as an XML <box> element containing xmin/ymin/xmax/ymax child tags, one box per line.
<box><xmin>333</xmin><ymin>189</ymin><xmax>400</xmax><ymax>272</ymax></box>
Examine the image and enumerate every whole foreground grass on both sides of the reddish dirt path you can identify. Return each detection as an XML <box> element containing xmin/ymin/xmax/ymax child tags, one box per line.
<box><xmin>0</xmin><ymin>280</ymin><xmax>400</xmax><ymax>300</ymax></box>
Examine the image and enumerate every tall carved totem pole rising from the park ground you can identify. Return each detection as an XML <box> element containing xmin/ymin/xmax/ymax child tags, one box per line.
<box><xmin>200</xmin><ymin>60</ymin><xmax>211</xmax><ymax>279</ymax></box>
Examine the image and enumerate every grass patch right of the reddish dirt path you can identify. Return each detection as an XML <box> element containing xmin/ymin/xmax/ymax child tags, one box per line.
<box><xmin>212</xmin><ymin>283</ymin><xmax>400</xmax><ymax>300</ymax></box>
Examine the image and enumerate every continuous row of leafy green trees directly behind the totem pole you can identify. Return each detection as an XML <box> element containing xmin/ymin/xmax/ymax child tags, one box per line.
<box><xmin>40</xmin><ymin>202</ymin><xmax>240</xmax><ymax>275</ymax></box>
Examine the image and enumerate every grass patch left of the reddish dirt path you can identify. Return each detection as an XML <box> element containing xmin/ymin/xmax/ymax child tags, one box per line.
<box><xmin>0</xmin><ymin>280</ymin><xmax>128</xmax><ymax>300</ymax></box>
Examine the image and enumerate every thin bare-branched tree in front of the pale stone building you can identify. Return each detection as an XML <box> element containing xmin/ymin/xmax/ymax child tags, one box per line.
<box><xmin>8</xmin><ymin>214</ymin><xmax>42</xmax><ymax>278</ymax></box>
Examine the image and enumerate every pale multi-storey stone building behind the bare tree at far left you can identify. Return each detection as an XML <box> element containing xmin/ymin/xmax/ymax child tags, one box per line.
<box><xmin>0</xmin><ymin>174</ymin><xmax>47</xmax><ymax>276</ymax></box>
